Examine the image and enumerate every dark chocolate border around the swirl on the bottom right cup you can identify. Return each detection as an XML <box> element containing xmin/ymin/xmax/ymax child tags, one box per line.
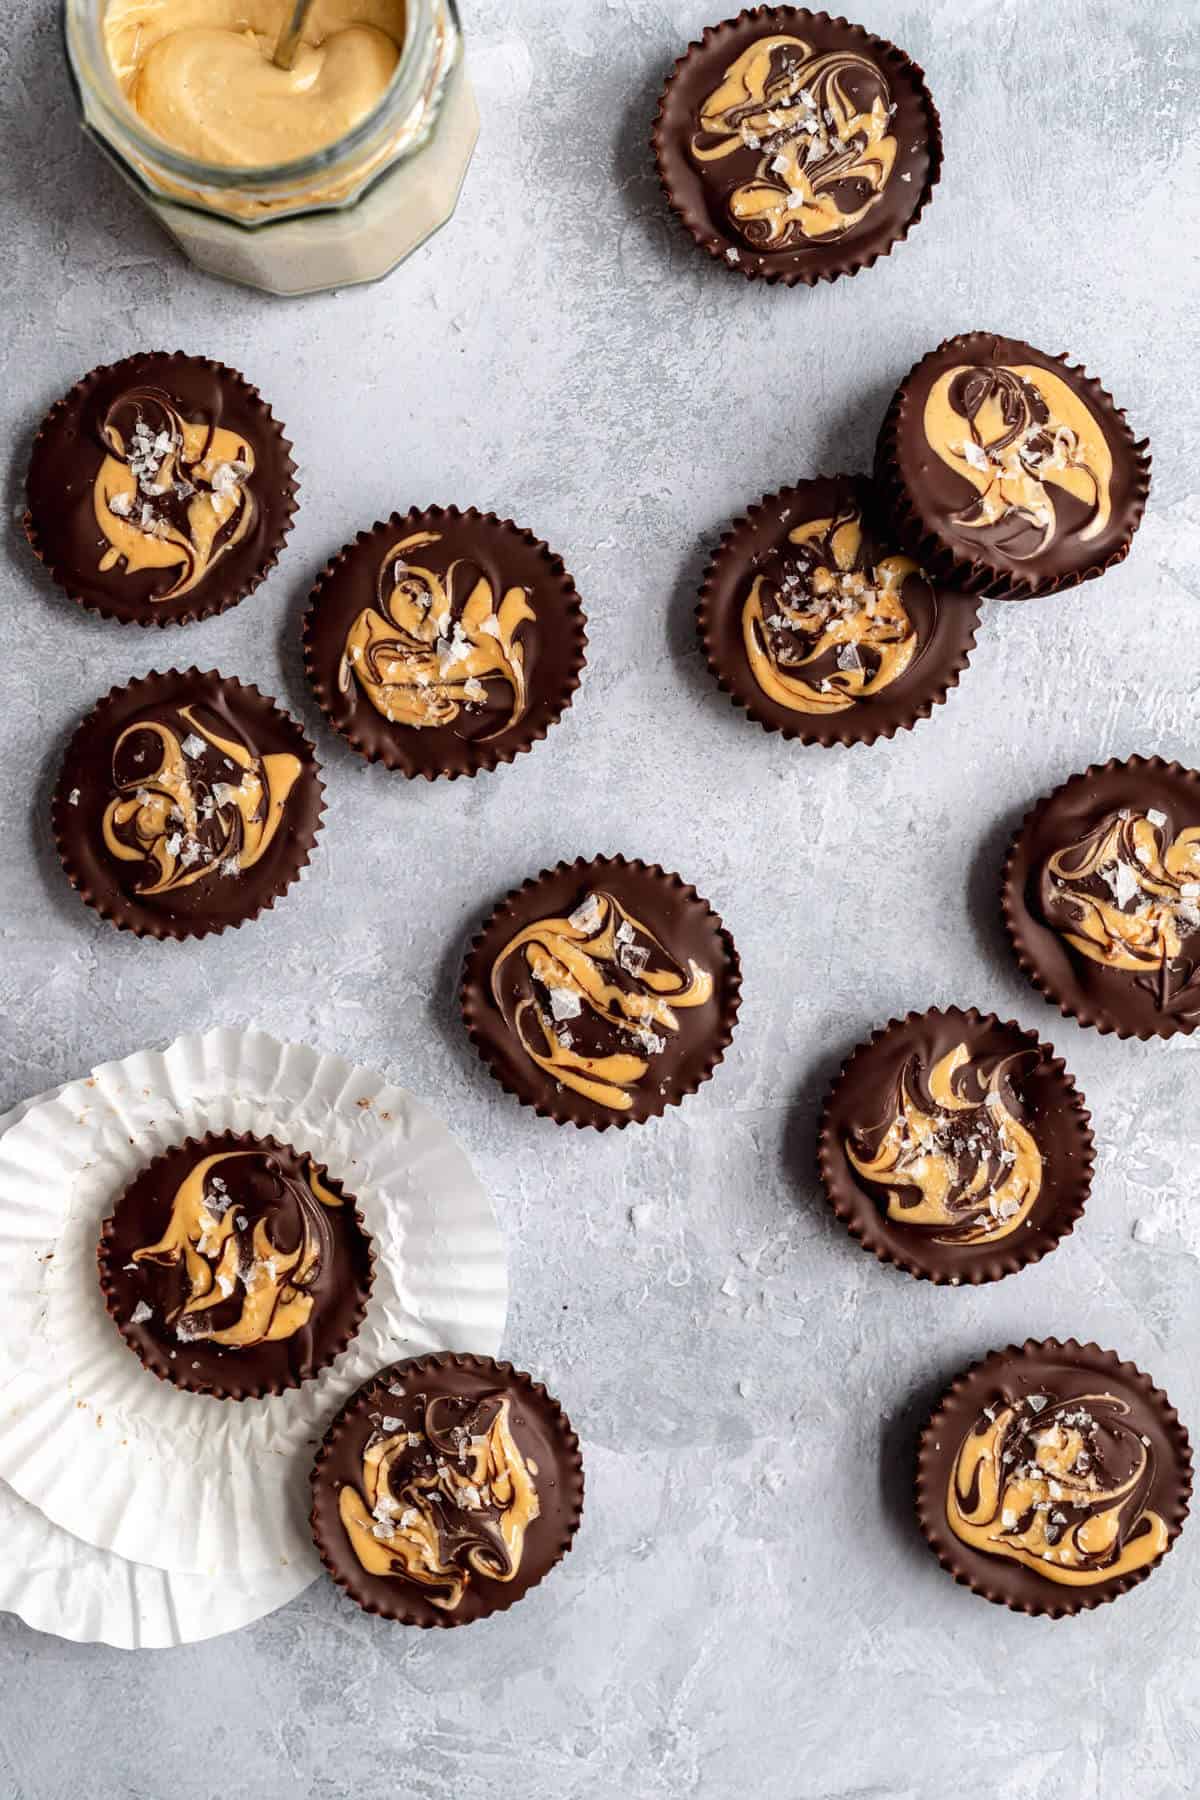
<box><xmin>916</xmin><ymin>1337</ymin><xmax>1191</xmax><ymax>1618</ymax></box>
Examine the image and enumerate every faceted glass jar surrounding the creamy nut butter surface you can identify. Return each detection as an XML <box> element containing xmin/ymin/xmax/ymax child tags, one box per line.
<box><xmin>63</xmin><ymin>0</ymin><xmax>479</xmax><ymax>293</ymax></box>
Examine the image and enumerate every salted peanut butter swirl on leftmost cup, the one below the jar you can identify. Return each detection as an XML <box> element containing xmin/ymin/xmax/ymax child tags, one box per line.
<box><xmin>92</xmin><ymin>387</ymin><xmax>255</xmax><ymax>603</ymax></box>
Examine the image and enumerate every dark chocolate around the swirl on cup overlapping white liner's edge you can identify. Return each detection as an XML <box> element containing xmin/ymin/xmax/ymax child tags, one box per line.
<box><xmin>311</xmin><ymin>1352</ymin><xmax>583</xmax><ymax>1629</ymax></box>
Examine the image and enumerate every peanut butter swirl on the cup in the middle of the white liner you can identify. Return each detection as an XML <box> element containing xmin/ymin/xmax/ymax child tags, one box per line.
<box><xmin>133</xmin><ymin>1150</ymin><xmax>344</xmax><ymax>1350</ymax></box>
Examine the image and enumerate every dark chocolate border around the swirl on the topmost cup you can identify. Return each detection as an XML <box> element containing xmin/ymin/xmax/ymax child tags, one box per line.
<box><xmin>651</xmin><ymin>5</ymin><xmax>941</xmax><ymax>288</ymax></box>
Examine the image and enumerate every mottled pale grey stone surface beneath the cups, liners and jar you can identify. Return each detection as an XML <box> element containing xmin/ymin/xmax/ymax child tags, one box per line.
<box><xmin>0</xmin><ymin>0</ymin><xmax>1200</xmax><ymax>1800</ymax></box>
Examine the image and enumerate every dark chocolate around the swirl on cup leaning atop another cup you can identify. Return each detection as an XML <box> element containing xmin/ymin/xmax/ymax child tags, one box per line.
<box><xmin>874</xmin><ymin>331</ymin><xmax>1150</xmax><ymax>599</ymax></box>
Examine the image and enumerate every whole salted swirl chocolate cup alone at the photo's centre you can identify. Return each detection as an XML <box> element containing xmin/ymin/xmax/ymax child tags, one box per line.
<box><xmin>461</xmin><ymin>857</ymin><xmax>741</xmax><ymax>1130</ymax></box>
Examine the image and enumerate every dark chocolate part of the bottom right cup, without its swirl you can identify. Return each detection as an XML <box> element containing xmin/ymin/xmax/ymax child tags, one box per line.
<box><xmin>916</xmin><ymin>1337</ymin><xmax>1193</xmax><ymax>1618</ymax></box>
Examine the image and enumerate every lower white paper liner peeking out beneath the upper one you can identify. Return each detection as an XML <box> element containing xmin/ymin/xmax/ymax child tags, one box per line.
<box><xmin>0</xmin><ymin>1089</ymin><xmax>315</xmax><ymax>1651</ymax></box>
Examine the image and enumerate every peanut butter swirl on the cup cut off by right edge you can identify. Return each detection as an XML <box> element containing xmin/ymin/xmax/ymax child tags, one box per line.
<box><xmin>1040</xmin><ymin>806</ymin><xmax>1200</xmax><ymax>1008</ymax></box>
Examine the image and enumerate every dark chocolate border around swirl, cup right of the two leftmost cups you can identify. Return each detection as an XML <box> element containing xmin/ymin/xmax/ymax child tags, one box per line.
<box><xmin>304</xmin><ymin>506</ymin><xmax>588</xmax><ymax>781</ymax></box>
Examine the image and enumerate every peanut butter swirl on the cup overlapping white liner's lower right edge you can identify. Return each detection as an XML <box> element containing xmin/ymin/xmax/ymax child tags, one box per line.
<box><xmin>338</xmin><ymin>1393</ymin><xmax>542</xmax><ymax>1613</ymax></box>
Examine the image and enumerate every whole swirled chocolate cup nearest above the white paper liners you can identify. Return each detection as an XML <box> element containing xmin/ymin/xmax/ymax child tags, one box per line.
<box><xmin>50</xmin><ymin>668</ymin><xmax>324</xmax><ymax>940</ymax></box>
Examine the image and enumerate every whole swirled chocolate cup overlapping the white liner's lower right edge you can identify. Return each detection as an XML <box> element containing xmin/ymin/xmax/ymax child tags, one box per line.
<box><xmin>311</xmin><ymin>1354</ymin><xmax>583</xmax><ymax>1629</ymax></box>
